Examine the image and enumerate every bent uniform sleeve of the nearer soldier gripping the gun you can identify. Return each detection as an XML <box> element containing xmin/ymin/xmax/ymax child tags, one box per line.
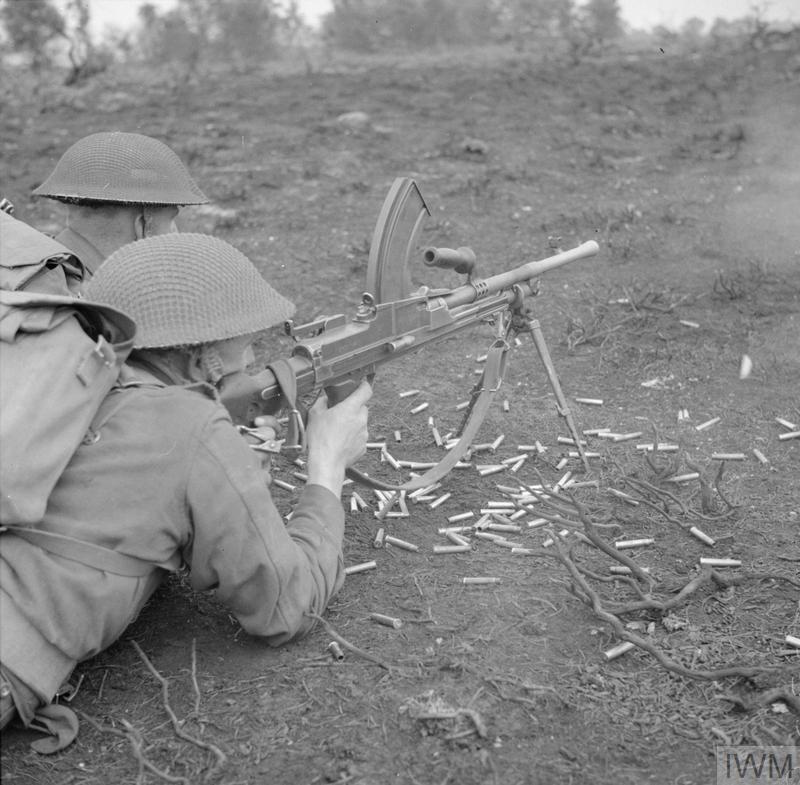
<box><xmin>183</xmin><ymin>410</ymin><xmax>344</xmax><ymax>646</ymax></box>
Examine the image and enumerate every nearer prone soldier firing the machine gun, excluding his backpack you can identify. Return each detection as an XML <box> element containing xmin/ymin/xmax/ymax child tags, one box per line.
<box><xmin>0</xmin><ymin>233</ymin><xmax>372</xmax><ymax>751</ymax></box>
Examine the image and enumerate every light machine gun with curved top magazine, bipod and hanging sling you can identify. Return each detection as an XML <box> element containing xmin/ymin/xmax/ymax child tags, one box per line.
<box><xmin>220</xmin><ymin>178</ymin><xmax>598</xmax><ymax>490</ymax></box>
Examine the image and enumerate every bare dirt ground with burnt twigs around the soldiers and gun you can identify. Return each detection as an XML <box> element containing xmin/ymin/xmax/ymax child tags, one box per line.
<box><xmin>0</xmin><ymin>41</ymin><xmax>800</xmax><ymax>785</ymax></box>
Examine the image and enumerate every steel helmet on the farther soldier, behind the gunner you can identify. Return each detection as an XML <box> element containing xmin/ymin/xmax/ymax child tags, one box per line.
<box><xmin>33</xmin><ymin>131</ymin><xmax>209</xmax><ymax>205</ymax></box>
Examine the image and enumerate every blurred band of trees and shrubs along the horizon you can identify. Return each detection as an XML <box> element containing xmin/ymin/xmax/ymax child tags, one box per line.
<box><xmin>0</xmin><ymin>0</ymin><xmax>800</xmax><ymax>84</ymax></box>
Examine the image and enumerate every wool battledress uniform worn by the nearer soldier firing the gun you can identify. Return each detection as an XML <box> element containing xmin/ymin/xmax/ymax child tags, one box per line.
<box><xmin>0</xmin><ymin>364</ymin><xmax>344</xmax><ymax>740</ymax></box>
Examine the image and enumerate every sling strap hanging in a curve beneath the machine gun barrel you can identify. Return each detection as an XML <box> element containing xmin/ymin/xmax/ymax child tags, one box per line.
<box><xmin>345</xmin><ymin>338</ymin><xmax>510</xmax><ymax>491</ymax></box>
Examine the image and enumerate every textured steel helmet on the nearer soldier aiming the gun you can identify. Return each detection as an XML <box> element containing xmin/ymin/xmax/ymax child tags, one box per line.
<box><xmin>85</xmin><ymin>232</ymin><xmax>295</xmax><ymax>349</ymax></box>
